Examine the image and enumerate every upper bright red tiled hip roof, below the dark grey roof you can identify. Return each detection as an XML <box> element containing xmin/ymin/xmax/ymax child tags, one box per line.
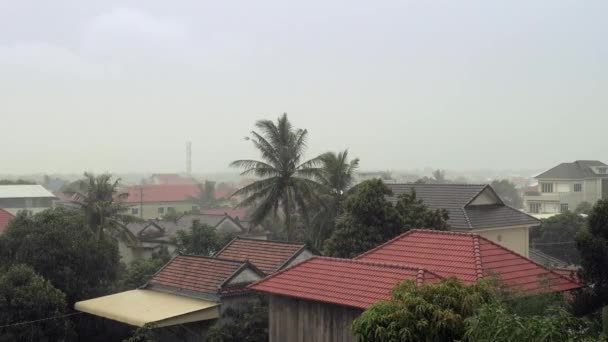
<box><xmin>356</xmin><ymin>229</ymin><xmax>581</xmax><ymax>292</ymax></box>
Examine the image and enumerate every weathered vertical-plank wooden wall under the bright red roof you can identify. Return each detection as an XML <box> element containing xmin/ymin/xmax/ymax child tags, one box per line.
<box><xmin>269</xmin><ymin>295</ymin><xmax>362</xmax><ymax>342</ymax></box>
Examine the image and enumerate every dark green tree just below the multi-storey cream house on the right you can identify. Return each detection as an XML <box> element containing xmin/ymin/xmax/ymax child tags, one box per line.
<box><xmin>530</xmin><ymin>212</ymin><xmax>587</xmax><ymax>264</ymax></box>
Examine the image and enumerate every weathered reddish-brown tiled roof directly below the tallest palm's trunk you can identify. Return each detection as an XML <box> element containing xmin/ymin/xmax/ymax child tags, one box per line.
<box><xmin>215</xmin><ymin>237</ymin><xmax>306</xmax><ymax>274</ymax></box>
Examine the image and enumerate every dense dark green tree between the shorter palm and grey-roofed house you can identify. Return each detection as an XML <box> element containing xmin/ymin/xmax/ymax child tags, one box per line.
<box><xmin>324</xmin><ymin>179</ymin><xmax>448</xmax><ymax>258</ymax></box>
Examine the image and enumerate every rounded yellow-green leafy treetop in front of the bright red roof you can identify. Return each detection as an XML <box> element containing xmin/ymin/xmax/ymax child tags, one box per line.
<box><xmin>352</xmin><ymin>278</ymin><xmax>494</xmax><ymax>342</ymax></box>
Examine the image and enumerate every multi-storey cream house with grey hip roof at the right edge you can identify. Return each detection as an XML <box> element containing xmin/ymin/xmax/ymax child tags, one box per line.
<box><xmin>524</xmin><ymin>160</ymin><xmax>608</xmax><ymax>214</ymax></box>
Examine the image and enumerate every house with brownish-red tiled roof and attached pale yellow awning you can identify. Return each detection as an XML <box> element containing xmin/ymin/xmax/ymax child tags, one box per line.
<box><xmin>74</xmin><ymin>255</ymin><xmax>264</xmax><ymax>341</ymax></box>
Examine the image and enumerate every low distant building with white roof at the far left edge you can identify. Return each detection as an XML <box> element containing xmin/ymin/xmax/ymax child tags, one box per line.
<box><xmin>0</xmin><ymin>185</ymin><xmax>55</xmax><ymax>215</ymax></box>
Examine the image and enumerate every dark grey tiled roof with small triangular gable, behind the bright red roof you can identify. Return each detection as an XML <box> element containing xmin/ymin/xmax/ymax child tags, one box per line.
<box><xmin>386</xmin><ymin>183</ymin><xmax>540</xmax><ymax>230</ymax></box>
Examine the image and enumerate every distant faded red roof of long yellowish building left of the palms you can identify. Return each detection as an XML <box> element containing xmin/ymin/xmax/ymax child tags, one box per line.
<box><xmin>121</xmin><ymin>184</ymin><xmax>200</xmax><ymax>203</ymax></box>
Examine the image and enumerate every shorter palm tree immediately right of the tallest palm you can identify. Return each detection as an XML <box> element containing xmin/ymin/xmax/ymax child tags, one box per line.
<box><xmin>309</xmin><ymin>150</ymin><xmax>359</xmax><ymax>248</ymax></box>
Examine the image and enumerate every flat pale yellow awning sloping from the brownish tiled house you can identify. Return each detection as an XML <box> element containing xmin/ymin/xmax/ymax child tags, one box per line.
<box><xmin>74</xmin><ymin>289</ymin><xmax>219</xmax><ymax>327</ymax></box>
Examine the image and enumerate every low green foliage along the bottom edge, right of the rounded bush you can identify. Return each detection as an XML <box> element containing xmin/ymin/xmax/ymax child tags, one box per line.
<box><xmin>465</xmin><ymin>302</ymin><xmax>598</xmax><ymax>342</ymax></box>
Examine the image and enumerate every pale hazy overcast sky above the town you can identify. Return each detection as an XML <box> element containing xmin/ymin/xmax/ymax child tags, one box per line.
<box><xmin>0</xmin><ymin>0</ymin><xmax>608</xmax><ymax>173</ymax></box>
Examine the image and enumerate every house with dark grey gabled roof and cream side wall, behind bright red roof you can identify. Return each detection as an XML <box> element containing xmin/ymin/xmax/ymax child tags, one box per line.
<box><xmin>386</xmin><ymin>184</ymin><xmax>540</xmax><ymax>257</ymax></box>
